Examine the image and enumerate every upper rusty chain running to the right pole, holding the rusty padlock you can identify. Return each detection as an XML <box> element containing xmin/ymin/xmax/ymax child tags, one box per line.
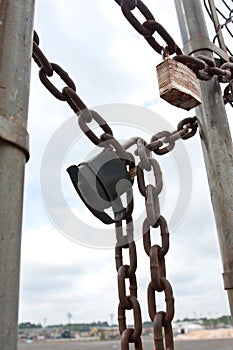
<box><xmin>115</xmin><ymin>0</ymin><xmax>233</xmax><ymax>105</ymax></box>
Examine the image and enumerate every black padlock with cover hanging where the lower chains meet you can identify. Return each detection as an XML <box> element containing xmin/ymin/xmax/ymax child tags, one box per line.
<box><xmin>67</xmin><ymin>149</ymin><xmax>133</xmax><ymax>224</ymax></box>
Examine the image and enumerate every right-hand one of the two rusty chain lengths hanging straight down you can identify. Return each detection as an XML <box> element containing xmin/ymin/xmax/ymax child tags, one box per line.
<box><xmin>138</xmin><ymin>154</ymin><xmax>174</xmax><ymax>350</ymax></box>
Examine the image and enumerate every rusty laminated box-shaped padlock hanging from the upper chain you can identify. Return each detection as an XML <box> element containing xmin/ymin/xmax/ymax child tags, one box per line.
<box><xmin>156</xmin><ymin>58</ymin><xmax>201</xmax><ymax>111</ymax></box>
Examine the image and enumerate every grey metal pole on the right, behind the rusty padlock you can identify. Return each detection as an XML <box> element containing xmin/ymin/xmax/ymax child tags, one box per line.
<box><xmin>175</xmin><ymin>0</ymin><xmax>233</xmax><ymax>317</ymax></box>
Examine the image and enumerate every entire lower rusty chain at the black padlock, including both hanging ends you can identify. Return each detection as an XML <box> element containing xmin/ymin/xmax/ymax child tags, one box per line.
<box><xmin>33</xmin><ymin>28</ymin><xmax>199</xmax><ymax>350</ymax></box>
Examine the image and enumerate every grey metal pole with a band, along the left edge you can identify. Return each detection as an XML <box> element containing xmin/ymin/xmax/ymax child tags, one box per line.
<box><xmin>0</xmin><ymin>0</ymin><xmax>34</xmax><ymax>350</ymax></box>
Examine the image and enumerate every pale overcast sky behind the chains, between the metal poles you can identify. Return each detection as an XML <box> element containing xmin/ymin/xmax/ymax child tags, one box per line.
<box><xmin>19</xmin><ymin>0</ymin><xmax>232</xmax><ymax>324</ymax></box>
